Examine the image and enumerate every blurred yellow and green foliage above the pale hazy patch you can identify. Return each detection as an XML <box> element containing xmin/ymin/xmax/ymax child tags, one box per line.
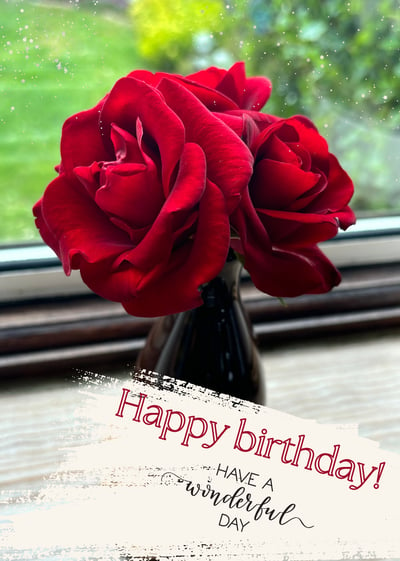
<box><xmin>130</xmin><ymin>0</ymin><xmax>400</xmax><ymax>128</ymax></box>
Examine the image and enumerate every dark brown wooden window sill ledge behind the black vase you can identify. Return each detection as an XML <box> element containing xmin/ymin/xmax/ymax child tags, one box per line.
<box><xmin>0</xmin><ymin>263</ymin><xmax>400</xmax><ymax>379</ymax></box>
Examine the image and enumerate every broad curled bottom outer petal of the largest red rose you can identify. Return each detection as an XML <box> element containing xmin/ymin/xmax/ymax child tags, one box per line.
<box><xmin>81</xmin><ymin>176</ymin><xmax>230</xmax><ymax>317</ymax></box>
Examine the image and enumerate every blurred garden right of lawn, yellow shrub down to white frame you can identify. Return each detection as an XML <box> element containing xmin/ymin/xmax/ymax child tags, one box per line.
<box><xmin>130</xmin><ymin>0</ymin><xmax>400</xmax><ymax>212</ymax></box>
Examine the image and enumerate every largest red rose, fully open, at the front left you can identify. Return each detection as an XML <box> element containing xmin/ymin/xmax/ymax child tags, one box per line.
<box><xmin>34</xmin><ymin>73</ymin><xmax>253</xmax><ymax>316</ymax></box>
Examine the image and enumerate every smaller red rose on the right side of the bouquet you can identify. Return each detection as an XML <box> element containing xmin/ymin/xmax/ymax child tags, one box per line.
<box><xmin>231</xmin><ymin>116</ymin><xmax>355</xmax><ymax>297</ymax></box>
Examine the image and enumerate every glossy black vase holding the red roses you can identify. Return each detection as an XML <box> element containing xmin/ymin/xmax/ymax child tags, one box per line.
<box><xmin>137</xmin><ymin>251</ymin><xmax>265</xmax><ymax>403</ymax></box>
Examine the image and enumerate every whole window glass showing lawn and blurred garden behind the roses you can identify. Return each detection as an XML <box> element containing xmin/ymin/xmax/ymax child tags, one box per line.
<box><xmin>0</xmin><ymin>0</ymin><xmax>400</xmax><ymax>243</ymax></box>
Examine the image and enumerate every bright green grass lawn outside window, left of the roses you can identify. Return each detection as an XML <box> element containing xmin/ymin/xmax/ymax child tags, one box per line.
<box><xmin>0</xmin><ymin>0</ymin><xmax>141</xmax><ymax>242</ymax></box>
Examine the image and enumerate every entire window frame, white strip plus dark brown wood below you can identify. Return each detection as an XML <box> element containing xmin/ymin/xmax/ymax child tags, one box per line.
<box><xmin>0</xmin><ymin>217</ymin><xmax>400</xmax><ymax>383</ymax></box>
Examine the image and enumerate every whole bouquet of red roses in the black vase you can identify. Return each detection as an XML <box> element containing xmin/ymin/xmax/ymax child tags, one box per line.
<box><xmin>33</xmin><ymin>63</ymin><xmax>354</xmax><ymax>317</ymax></box>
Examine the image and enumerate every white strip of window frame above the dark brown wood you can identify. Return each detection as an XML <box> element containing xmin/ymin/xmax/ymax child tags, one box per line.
<box><xmin>0</xmin><ymin>215</ymin><xmax>400</xmax><ymax>305</ymax></box>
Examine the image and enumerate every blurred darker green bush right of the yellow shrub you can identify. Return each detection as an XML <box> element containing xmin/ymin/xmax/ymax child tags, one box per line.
<box><xmin>223</xmin><ymin>0</ymin><xmax>400</xmax><ymax>128</ymax></box>
